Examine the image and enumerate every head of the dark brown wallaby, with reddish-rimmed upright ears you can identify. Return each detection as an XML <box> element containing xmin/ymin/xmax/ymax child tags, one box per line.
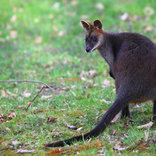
<box><xmin>81</xmin><ymin>20</ymin><xmax>104</xmax><ymax>53</ymax></box>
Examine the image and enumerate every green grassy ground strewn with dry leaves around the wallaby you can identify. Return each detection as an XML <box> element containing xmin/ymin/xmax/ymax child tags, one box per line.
<box><xmin>0</xmin><ymin>0</ymin><xmax>156</xmax><ymax>155</ymax></box>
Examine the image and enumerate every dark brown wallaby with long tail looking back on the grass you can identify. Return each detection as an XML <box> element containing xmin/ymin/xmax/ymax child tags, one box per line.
<box><xmin>46</xmin><ymin>20</ymin><xmax>156</xmax><ymax>147</ymax></box>
